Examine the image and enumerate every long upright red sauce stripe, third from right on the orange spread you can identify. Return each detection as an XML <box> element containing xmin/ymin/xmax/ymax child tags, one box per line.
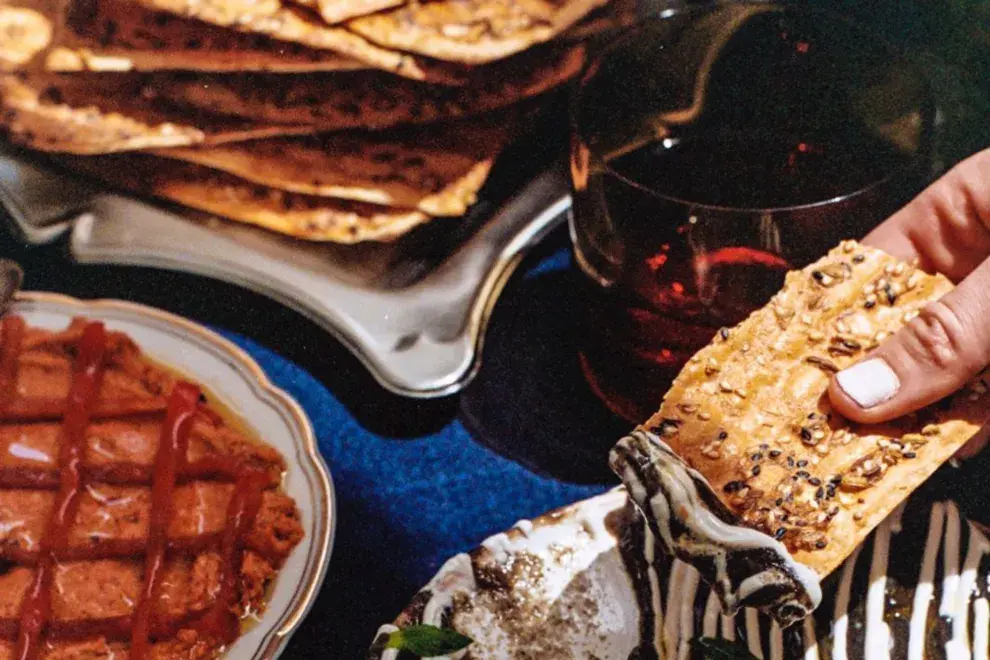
<box><xmin>13</xmin><ymin>321</ymin><xmax>106</xmax><ymax>660</ymax></box>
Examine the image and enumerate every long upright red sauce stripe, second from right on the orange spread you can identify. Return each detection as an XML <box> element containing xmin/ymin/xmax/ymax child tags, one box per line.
<box><xmin>128</xmin><ymin>382</ymin><xmax>200</xmax><ymax>660</ymax></box>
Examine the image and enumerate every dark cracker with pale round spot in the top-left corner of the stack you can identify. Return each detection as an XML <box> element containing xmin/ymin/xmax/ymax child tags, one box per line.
<box><xmin>0</xmin><ymin>0</ymin><xmax>367</xmax><ymax>73</ymax></box>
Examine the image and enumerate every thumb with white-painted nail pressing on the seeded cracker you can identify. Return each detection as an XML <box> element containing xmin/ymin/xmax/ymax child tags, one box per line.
<box><xmin>829</xmin><ymin>261</ymin><xmax>990</xmax><ymax>423</ymax></box>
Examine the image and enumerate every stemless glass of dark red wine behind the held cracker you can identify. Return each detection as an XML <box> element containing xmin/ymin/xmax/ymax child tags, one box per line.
<box><xmin>570</xmin><ymin>2</ymin><xmax>935</xmax><ymax>421</ymax></box>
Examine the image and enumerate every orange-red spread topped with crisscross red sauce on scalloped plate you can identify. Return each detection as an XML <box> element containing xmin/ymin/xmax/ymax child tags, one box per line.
<box><xmin>0</xmin><ymin>316</ymin><xmax>303</xmax><ymax>660</ymax></box>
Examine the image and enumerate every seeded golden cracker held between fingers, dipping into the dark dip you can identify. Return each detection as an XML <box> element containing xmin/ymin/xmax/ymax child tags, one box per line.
<box><xmin>643</xmin><ymin>241</ymin><xmax>990</xmax><ymax>577</ymax></box>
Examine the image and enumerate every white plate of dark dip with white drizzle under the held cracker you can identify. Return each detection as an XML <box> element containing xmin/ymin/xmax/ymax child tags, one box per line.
<box><xmin>369</xmin><ymin>489</ymin><xmax>990</xmax><ymax>660</ymax></box>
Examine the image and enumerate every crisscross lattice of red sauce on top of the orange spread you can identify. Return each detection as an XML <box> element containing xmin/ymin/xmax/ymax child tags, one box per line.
<box><xmin>0</xmin><ymin>316</ymin><xmax>280</xmax><ymax>660</ymax></box>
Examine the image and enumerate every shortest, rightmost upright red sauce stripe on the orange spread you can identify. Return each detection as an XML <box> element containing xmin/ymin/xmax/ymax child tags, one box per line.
<box><xmin>192</xmin><ymin>469</ymin><xmax>269</xmax><ymax>643</ymax></box>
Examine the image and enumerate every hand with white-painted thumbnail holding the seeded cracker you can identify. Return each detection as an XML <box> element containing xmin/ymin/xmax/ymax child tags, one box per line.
<box><xmin>829</xmin><ymin>149</ymin><xmax>990</xmax><ymax>457</ymax></box>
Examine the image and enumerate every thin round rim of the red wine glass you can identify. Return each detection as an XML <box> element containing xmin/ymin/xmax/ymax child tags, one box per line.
<box><xmin>569</xmin><ymin>0</ymin><xmax>935</xmax><ymax>214</ymax></box>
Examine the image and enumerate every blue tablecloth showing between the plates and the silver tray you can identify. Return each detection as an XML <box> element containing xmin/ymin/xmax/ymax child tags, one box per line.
<box><xmin>221</xmin><ymin>241</ymin><xmax>606</xmax><ymax>658</ymax></box>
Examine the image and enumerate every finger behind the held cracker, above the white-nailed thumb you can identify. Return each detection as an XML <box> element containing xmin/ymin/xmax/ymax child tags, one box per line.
<box><xmin>863</xmin><ymin>149</ymin><xmax>990</xmax><ymax>282</ymax></box>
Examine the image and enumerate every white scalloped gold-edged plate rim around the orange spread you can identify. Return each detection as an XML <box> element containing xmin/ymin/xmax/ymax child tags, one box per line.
<box><xmin>12</xmin><ymin>293</ymin><xmax>336</xmax><ymax>660</ymax></box>
